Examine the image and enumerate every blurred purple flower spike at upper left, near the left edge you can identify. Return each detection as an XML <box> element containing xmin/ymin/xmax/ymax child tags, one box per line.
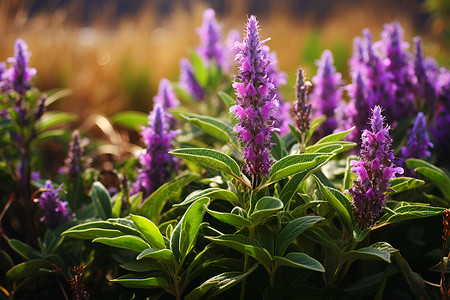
<box><xmin>7</xmin><ymin>39</ymin><xmax>36</xmax><ymax>94</ymax></box>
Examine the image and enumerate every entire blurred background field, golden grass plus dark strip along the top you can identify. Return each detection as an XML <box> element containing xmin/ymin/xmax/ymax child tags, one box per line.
<box><xmin>0</xmin><ymin>0</ymin><xmax>450</xmax><ymax>121</ymax></box>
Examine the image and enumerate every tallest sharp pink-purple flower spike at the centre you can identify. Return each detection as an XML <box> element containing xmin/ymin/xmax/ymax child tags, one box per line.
<box><xmin>230</xmin><ymin>16</ymin><xmax>278</xmax><ymax>176</ymax></box>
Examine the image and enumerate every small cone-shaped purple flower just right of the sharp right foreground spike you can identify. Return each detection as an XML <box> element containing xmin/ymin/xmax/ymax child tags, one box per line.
<box><xmin>402</xmin><ymin>112</ymin><xmax>433</xmax><ymax>175</ymax></box>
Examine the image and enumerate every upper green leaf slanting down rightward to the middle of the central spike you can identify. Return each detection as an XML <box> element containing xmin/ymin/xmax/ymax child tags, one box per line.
<box><xmin>180</xmin><ymin>112</ymin><xmax>238</xmax><ymax>145</ymax></box>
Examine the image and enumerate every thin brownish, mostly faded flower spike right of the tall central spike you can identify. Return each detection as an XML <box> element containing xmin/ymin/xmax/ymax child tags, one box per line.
<box><xmin>291</xmin><ymin>68</ymin><xmax>311</xmax><ymax>133</ymax></box>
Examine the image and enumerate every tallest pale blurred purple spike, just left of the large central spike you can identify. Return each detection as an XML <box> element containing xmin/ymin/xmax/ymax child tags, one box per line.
<box><xmin>196</xmin><ymin>8</ymin><xmax>225</xmax><ymax>67</ymax></box>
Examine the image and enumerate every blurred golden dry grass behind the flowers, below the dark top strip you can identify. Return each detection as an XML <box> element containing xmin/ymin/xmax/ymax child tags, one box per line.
<box><xmin>0</xmin><ymin>0</ymin><xmax>442</xmax><ymax>118</ymax></box>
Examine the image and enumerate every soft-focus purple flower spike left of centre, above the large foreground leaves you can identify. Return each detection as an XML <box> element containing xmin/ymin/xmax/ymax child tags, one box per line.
<box><xmin>130</xmin><ymin>104</ymin><xmax>179</xmax><ymax>198</ymax></box>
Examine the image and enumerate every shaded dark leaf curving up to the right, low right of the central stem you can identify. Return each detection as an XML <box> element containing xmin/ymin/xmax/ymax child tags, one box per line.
<box><xmin>275</xmin><ymin>216</ymin><xmax>325</xmax><ymax>256</ymax></box>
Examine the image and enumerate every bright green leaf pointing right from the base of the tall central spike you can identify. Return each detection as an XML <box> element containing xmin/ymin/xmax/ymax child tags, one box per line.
<box><xmin>269</xmin><ymin>153</ymin><xmax>333</xmax><ymax>183</ymax></box>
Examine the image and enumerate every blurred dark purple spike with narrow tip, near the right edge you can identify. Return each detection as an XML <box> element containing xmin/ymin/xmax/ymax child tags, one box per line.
<box><xmin>414</xmin><ymin>37</ymin><xmax>437</xmax><ymax>110</ymax></box>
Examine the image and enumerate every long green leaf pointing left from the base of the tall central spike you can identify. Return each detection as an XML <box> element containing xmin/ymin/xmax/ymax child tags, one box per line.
<box><xmin>169</xmin><ymin>148</ymin><xmax>241</xmax><ymax>177</ymax></box>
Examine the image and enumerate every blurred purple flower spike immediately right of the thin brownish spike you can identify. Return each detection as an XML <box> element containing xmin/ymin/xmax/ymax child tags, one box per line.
<box><xmin>310</xmin><ymin>50</ymin><xmax>342</xmax><ymax>136</ymax></box>
